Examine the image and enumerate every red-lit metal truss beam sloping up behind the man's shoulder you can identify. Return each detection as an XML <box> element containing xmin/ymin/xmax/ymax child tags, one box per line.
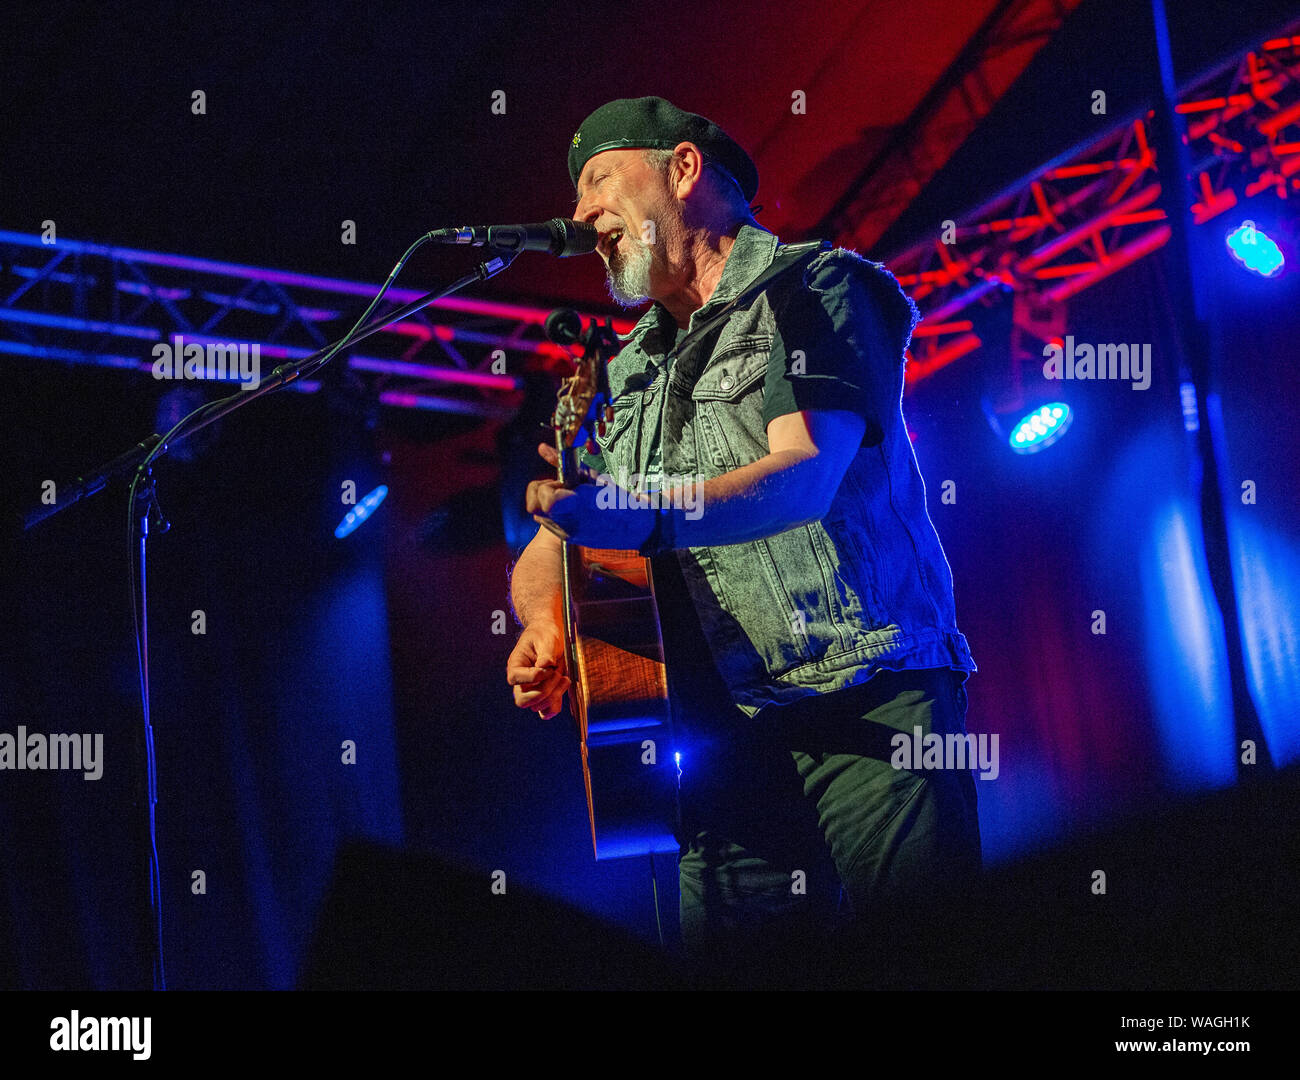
<box><xmin>887</xmin><ymin>23</ymin><xmax>1300</xmax><ymax>385</ymax></box>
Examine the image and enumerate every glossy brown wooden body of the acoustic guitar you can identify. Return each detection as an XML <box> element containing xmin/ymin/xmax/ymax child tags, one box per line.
<box><xmin>564</xmin><ymin>542</ymin><xmax>677</xmax><ymax>859</ymax></box>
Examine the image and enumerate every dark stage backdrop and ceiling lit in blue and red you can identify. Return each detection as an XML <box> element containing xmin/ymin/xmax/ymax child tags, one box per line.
<box><xmin>0</xmin><ymin>3</ymin><xmax>1300</xmax><ymax>988</ymax></box>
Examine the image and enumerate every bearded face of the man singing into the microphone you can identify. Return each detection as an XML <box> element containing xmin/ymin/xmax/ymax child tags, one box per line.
<box><xmin>573</xmin><ymin>149</ymin><xmax>677</xmax><ymax>308</ymax></box>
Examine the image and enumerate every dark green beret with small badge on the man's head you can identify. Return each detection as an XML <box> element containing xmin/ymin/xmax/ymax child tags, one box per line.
<box><xmin>569</xmin><ymin>97</ymin><xmax>758</xmax><ymax>201</ymax></box>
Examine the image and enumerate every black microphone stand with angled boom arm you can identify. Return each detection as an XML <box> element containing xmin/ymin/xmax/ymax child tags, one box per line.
<box><xmin>17</xmin><ymin>243</ymin><xmax>520</xmax><ymax>990</ymax></box>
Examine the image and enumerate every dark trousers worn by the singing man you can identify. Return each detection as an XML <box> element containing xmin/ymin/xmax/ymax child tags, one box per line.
<box><xmin>679</xmin><ymin>668</ymin><xmax>980</xmax><ymax>967</ymax></box>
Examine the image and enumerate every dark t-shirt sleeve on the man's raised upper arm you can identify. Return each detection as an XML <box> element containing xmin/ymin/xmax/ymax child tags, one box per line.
<box><xmin>763</xmin><ymin>248</ymin><xmax>917</xmax><ymax>446</ymax></box>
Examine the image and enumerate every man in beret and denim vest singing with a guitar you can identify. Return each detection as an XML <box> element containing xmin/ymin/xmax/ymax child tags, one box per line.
<box><xmin>507</xmin><ymin>97</ymin><xmax>980</xmax><ymax>963</ymax></box>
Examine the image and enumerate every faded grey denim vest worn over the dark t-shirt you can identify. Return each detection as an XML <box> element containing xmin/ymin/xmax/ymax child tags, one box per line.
<box><xmin>590</xmin><ymin>225</ymin><xmax>976</xmax><ymax>716</ymax></box>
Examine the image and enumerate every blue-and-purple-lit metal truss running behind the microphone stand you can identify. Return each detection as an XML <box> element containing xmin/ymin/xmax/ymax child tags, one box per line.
<box><xmin>0</xmin><ymin>231</ymin><xmax>632</xmax><ymax>418</ymax></box>
